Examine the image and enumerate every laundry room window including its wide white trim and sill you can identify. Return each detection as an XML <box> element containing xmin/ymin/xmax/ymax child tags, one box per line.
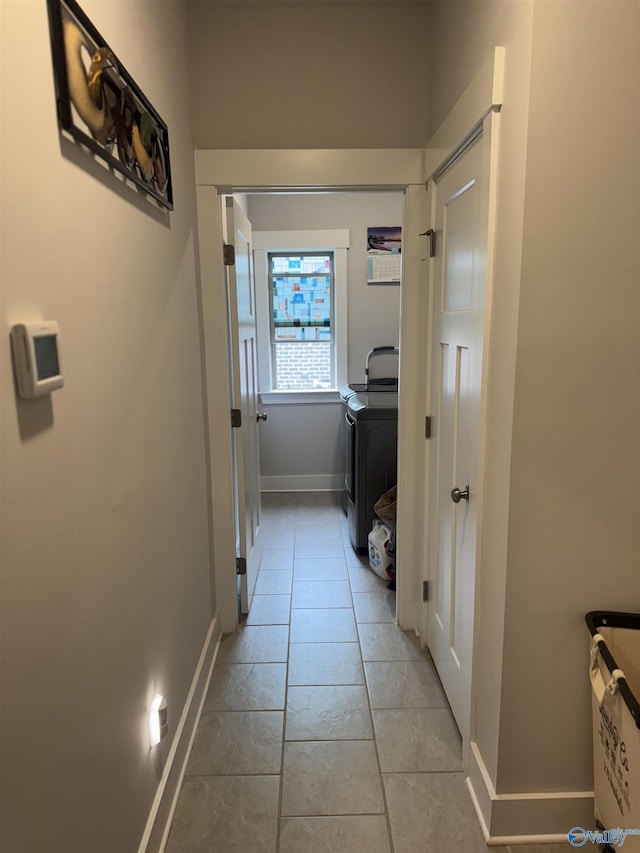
<box><xmin>252</xmin><ymin>229</ymin><xmax>349</xmax><ymax>403</ymax></box>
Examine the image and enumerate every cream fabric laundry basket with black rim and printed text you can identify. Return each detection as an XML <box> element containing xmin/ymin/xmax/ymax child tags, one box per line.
<box><xmin>585</xmin><ymin>611</ymin><xmax>640</xmax><ymax>853</ymax></box>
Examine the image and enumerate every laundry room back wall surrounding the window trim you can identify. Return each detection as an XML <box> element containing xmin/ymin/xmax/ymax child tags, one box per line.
<box><xmin>249</xmin><ymin>192</ymin><xmax>404</xmax><ymax>488</ymax></box>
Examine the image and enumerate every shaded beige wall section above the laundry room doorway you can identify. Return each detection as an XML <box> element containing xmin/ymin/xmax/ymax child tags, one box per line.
<box><xmin>190</xmin><ymin>2</ymin><xmax>429</xmax><ymax>148</ymax></box>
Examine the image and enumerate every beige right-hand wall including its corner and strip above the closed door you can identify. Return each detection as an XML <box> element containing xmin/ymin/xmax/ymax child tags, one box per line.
<box><xmin>431</xmin><ymin>0</ymin><xmax>640</xmax><ymax>835</ymax></box>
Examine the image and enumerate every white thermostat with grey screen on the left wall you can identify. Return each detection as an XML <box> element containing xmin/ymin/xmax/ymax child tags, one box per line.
<box><xmin>11</xmin><ymin>320</ymin><xmax>64</xmax><ymax>399</ymax></box>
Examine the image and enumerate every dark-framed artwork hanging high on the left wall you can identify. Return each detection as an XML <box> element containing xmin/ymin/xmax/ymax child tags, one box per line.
<box><xmin>47</xmin><ymin>0</ymin><xmax>173</xmax><ymax>210</ymax></box>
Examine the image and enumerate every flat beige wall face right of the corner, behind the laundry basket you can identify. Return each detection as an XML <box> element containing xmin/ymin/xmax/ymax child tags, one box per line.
<box><xmin>500</xmin><ymin>0</ymin><xmax>640</xmax><ymax>790</ymax></box>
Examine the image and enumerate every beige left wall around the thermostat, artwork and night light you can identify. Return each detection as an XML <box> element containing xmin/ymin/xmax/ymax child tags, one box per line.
<box><xmin>0</xmin><ymin>0</ymin><xmax>214</xmax><ymax>853</ymax></box>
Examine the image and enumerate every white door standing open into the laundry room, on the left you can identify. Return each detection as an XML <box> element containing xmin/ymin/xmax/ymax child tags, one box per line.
<box><xmin>227</xmin><ymin>198</ymin><xmax>261</xmax><ymax>613</ymax></box>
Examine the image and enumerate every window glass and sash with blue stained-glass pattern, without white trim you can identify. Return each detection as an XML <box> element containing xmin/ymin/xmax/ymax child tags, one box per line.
<box><xmin>269</xmin><ymin>252</ymin><xmax>335</xmax><ymax>391</ymax></box>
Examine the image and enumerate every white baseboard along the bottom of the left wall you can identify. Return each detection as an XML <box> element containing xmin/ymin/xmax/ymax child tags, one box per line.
<box><xmin>138</xmin><ymin>611</ymin><xmax>221</xmax><ymax>853</ymax></box>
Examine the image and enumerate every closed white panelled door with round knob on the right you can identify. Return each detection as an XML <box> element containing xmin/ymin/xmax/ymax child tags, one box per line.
<box><xmin>428</xmin><ymin>131</ymin><xmax>488</xmax><ymax>751</ymax></box>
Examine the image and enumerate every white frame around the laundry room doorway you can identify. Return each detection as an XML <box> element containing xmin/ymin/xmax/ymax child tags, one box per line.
<box><xmin>195</xmin><ymin>149</ymin><xmax>437</xmax><ymax>632</ymax></box>
